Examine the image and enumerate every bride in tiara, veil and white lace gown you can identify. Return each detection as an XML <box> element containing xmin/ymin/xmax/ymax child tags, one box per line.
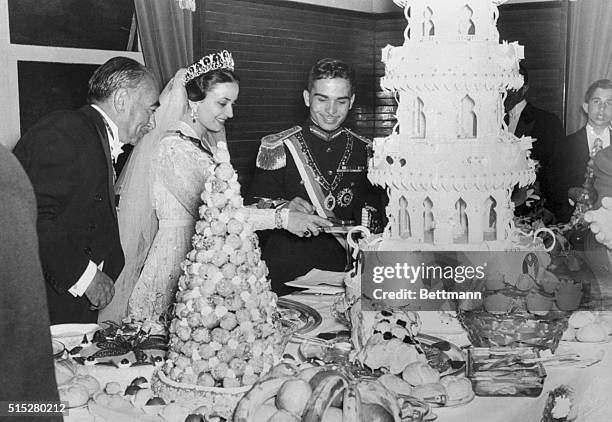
<box><xmin>99</xmin><ymin>51</ymin><xmax>331</xmax><ymax>322</ymax></box>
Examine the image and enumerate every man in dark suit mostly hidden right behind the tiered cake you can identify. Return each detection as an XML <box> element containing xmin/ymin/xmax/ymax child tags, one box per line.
<box><xmin>504</xmin><ymin>64</ymin><xmax>565</xmax><ymax>221</ymax></box>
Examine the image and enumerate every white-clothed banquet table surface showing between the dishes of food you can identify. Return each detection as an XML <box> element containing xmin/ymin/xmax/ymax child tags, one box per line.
<box><xmin>64</xmin><ymin>294</ymin><xmax>612</xmax><ymax>422</ymax></box>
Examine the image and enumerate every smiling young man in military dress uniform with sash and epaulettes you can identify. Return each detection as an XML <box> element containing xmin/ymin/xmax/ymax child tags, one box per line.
<box><xmin>249</xmin><ymin>59</ymin><xmax>380</xmax><ymax>294</ymax></box>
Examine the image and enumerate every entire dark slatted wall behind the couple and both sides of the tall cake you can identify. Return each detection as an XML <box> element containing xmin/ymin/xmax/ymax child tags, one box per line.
<box><xmin>196</xmin><ymin>0</ymin><xmax>567</xmax><ymax>186</ymax></box>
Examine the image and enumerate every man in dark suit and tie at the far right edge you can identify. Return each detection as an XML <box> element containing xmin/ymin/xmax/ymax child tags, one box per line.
<box><xmin>552</xmin><ymin>79</ymin><xmax>612</xmax><ymax>222</ymax></box>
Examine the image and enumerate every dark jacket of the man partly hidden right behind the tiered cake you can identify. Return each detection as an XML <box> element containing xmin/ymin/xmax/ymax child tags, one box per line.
<box><xmin>514</xmin><ymin>102</ymin><xmax>565</xmax><ymax>218</ymax></box>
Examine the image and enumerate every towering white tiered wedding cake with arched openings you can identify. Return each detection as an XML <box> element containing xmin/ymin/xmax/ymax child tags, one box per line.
<box><xmin>369</xmin><ymin>0</ymin><xmax>535</xmax><ymax>250</ymax></box>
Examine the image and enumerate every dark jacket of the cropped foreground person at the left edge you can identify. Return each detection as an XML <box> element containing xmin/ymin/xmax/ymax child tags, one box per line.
<box><xmin>0</xmin><ymin>145</ymin><xmax>62</xmax><ymax>421</ymax></box>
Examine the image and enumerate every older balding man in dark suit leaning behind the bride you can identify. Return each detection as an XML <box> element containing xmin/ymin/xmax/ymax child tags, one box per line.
<box><xmin>14</xmin><ymin>57</ymin><xmax>159</xmax><ymax>324</ymax></box>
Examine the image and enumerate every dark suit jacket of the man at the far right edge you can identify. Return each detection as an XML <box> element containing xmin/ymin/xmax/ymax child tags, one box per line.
<box><xmin>548</xmin><ymin>127</ymin><xmax>589</xmax><ymax>223</ymax></box>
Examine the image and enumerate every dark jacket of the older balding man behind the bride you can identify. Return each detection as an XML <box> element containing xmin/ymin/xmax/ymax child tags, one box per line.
<box><xmin>14</xmin><ymin>106</ymin><xmax>124</xmax><ymax>324</ymax></box>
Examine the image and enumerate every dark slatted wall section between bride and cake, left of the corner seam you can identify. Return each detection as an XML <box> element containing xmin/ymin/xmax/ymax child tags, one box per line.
<box><xmin>196</xmin><ymin>0</ymin><xmax>375</xmax><ymax>191</ymax></box>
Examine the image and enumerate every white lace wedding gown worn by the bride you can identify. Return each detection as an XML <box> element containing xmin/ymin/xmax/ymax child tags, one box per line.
<box><xmin>128</xmin><ymin>122</ymin><xmax>275</xmax><ymax>320</ymax></box>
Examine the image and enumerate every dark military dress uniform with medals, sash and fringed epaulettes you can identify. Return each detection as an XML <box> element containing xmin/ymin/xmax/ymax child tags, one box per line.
<box><xmin>247</xmin><ymin>121</ymin><xmax>381</xmax><ymax>295</ymax></box>
